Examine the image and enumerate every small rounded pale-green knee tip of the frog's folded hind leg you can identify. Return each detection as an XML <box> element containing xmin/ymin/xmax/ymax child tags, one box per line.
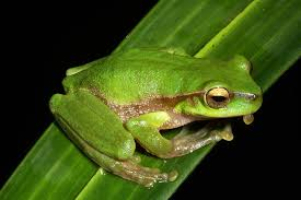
<box><xmin>117</xmin><ymin>139</ymin><xmax>136</xmax><ymax>160</ymax></box>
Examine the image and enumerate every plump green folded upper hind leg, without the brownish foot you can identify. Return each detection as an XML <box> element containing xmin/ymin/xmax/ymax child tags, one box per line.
<box><xmin>50</xmin><ymin>91</ymin><xmax>136</xmax><ymax>160</ymax></box>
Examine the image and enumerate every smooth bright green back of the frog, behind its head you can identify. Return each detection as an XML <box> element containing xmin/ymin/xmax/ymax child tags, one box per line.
<box><xmin>65</xmin><ymin>49</ymin><xmax>230</xmax><ymax>104</ymax></box>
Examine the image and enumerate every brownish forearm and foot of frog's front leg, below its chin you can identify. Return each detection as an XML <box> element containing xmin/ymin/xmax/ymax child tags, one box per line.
<box><xmin>159</xmin><ymin>123</ymin><xmax>233</xmax><ymax>158</ymax></box>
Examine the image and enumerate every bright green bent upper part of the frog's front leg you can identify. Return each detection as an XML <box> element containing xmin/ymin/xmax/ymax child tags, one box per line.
<box><xmin>126</xmin><ymin>111</ymin><xmax>173</xmax><ymax>157</ymax></box>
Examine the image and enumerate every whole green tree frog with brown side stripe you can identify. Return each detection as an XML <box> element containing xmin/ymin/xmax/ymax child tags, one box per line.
<box><xmin>50</xmin><ymin>49</ymin><xmax>262</xmax><ymax>187</ymax></box>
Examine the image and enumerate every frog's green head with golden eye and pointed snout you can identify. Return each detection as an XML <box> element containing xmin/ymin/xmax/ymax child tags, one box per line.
<box><xmin>176</xmin><ymin>55</ymin><xmax>262</xmax><ymax>124</ymax></box>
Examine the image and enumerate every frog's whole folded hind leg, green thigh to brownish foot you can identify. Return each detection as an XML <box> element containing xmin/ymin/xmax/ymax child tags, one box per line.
<box><xmin>50</xmin><ymin>91</ymin><xmax>176</xmax><ymax>187</ymax></box>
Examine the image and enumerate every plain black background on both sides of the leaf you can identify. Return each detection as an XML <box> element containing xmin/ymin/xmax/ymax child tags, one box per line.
<box><xmin>0</xmin><ymin>0</ymin><xmax>301</xmax><ymax>199</ymax></box>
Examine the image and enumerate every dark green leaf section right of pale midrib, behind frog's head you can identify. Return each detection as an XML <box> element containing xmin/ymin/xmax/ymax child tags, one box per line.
<box><xmin>196</xmin><ymin>0</ymin><xmax>301</xmax><ymax>91</ymax></box>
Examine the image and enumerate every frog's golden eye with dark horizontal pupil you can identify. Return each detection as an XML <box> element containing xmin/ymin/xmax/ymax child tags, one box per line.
<box><xmin>206</xmin><ymin>87</ymin><xmax>230</xmax><ymax>108</ymax></box>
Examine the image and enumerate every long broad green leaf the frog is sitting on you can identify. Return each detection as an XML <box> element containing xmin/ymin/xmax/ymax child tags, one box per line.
<box><xmin>0</xmin><ymin>0</ymin><xmax>301</xmax><ymax>199</ymax></box>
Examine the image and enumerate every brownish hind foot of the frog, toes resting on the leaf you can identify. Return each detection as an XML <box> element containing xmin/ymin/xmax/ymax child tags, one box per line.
<box><xmin>110</xmin><ymin>161</ymin><xmax>178</xmax><ymax>187</ymax></box>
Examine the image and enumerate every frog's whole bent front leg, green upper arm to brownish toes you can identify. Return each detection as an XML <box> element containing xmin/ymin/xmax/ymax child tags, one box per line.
<box><xmin>126</xmin><ymin>111</ymin><xmax>233</xmax><ymax>158</ymax></box>
